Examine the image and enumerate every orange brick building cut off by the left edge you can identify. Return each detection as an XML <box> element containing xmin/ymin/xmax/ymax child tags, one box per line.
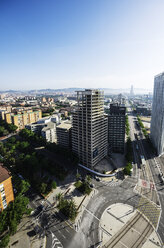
<box><xmin>0</xmin><ymin>164</ymin><xmax>14</xmax><ymax>211</ymax></box>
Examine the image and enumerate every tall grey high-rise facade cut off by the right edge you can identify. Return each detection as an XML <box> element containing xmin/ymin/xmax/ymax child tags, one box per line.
<box><xmin>150</xmin><ymin>72</ymin><xmax>164</xmax><ymax>155</ymax></box>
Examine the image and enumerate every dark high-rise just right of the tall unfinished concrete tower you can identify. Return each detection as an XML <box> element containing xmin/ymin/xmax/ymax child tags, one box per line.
<box><xmin>108</xmin><ymin>103</ymin><xmax>126</xmax><ymax>154</ymax></box>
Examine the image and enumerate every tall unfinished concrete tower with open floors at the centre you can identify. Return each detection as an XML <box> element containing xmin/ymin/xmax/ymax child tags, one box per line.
<box><xmin>72</xmin><ymin>89</ymin><xmax>108</xmax><ymax>168</ymax></box>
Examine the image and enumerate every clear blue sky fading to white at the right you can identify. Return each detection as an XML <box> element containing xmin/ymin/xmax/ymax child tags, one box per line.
<box><xmin>0</xmin><ymin>0</ymin><xmax>164</xmax><ymax>90</ymax></box>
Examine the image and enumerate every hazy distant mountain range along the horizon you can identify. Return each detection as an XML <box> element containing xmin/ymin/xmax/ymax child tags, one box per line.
<box><xmin>0</xmin><ymin>88</ymin><xmax>152</xmax><ymax>95</ymax></box>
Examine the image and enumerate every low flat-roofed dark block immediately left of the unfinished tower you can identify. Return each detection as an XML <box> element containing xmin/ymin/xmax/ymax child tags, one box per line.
<box><xmin>56</xmin><ymin>121</ymin><xmax>72</xmax><ymax>149</ymax></box>
